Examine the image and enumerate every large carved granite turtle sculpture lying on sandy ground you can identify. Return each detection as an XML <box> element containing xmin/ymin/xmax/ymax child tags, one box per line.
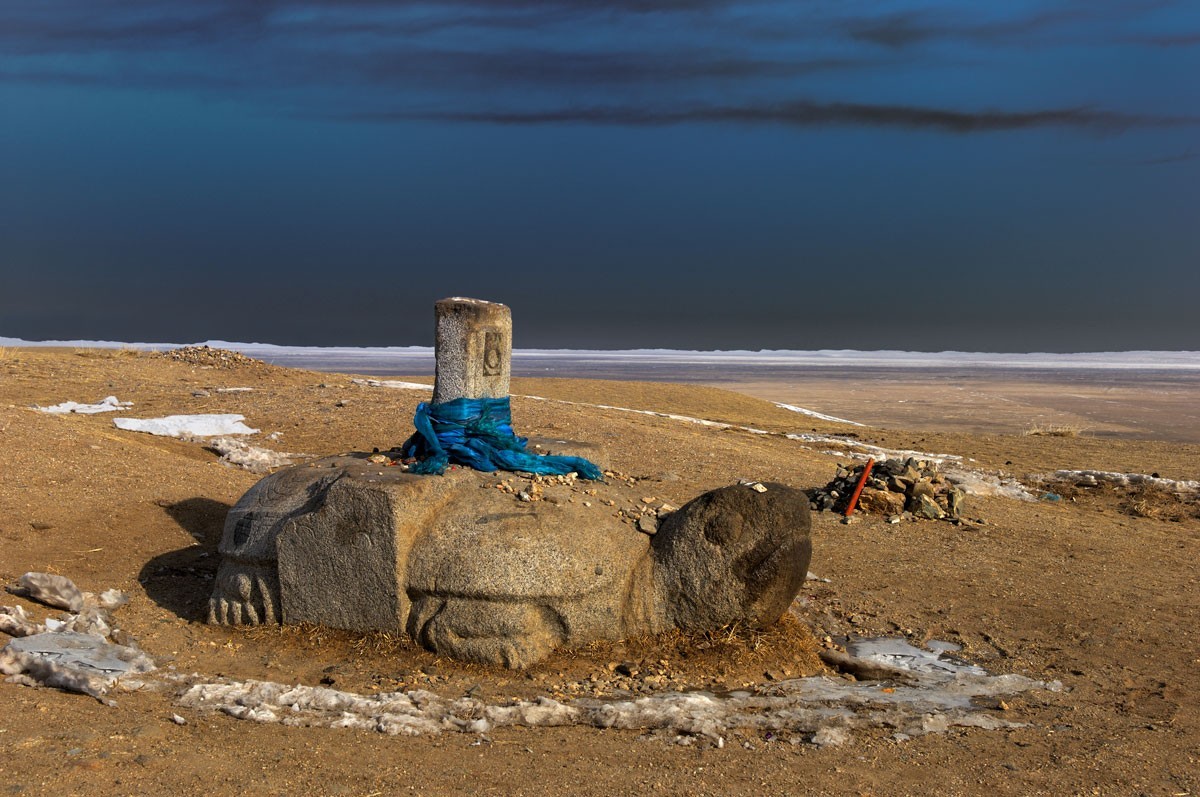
<box><xmin>209</xmin><ymin>455</ymin><xmax>811</xmax><ymax>667</ymax></box>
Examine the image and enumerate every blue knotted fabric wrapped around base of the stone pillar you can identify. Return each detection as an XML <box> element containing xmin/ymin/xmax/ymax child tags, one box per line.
<box><xmin>404</xmin><ymin>396</ymin><xmax>601</xmax><ymax>479</ymax></box>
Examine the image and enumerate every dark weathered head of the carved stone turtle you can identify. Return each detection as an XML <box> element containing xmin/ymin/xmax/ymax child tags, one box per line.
<box><xmin>652</xmin><ymin>484</ymin><xmax>812</xmax><ymax>630</ymax></box>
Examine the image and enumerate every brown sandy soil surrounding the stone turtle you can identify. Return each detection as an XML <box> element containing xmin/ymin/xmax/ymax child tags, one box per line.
<box><xmin>0</xmin><ymin>349</ymin><xmax>1200</xmax><ymax>795</ymax></box>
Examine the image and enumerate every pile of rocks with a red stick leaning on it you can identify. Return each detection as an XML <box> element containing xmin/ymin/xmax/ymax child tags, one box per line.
<box><xmin>809</xmin><ymin>457</ymin><xmax>966</xmax><ymax>521</ymax></box>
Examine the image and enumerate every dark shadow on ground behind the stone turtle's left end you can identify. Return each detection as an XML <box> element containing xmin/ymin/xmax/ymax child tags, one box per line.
<box><xmin>138</xmin><ymin>498</ymin><xmax>230</xmax><ymax>622</ymax></box>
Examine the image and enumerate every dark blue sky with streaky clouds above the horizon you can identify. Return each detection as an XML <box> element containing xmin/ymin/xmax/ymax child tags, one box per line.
<box><xmin>0</xmin><ymin>0</ymin><xmax>1200</xmax><ymax>352</ymax></box>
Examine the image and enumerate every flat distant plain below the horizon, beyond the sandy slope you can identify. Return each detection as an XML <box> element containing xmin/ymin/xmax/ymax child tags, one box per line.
<box><xmin>336</xmin><ymin>352</ymin><xmax>1200</xmax><ymax>443</ymax></box>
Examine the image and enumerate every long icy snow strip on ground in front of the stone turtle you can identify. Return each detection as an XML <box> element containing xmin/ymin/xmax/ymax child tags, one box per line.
<box><xmin>180</xmin><ymin>640</ymin><xmax>1061</xmax><ymax>744</ymax></box>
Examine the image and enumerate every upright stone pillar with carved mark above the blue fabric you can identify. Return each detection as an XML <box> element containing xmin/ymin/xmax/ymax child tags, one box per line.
<box><xmin>433</xmin><ymin>296</ymin><xmax>512</xmax><ymax>405</ymax></box>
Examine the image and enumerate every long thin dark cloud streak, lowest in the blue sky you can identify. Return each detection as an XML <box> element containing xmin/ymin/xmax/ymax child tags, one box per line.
<box><xmin>344</xmin><ymin>100</ymin><xmax>1200</xmax><ymax>133</ymax></box>
